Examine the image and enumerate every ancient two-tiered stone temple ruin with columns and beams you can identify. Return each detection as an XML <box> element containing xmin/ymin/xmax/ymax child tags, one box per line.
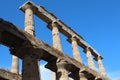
<box><xmin>0</xmin><ymin>1</ymin><xmax>110</xmax><ymax>80</ymax></box>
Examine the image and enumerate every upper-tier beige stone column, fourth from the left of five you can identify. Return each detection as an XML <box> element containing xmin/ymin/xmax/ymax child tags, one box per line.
<box><xmin>85</xmin><ymin>48</ymin><xmax>96</xmax><ymax>70</ymax></box>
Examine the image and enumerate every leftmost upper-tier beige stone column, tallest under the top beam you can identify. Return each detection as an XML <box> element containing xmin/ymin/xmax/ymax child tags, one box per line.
<box><xmin>25</xmin><ymin>5</ymin><xmax>35</xmax><ymax>35</ymax></box>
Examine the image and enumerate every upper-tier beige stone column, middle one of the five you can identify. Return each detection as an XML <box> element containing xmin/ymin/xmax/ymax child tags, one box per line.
<box><xmin>71</xmin><ymin>36</ymin><xmax>82</xmax><ymax>63</ymax></box>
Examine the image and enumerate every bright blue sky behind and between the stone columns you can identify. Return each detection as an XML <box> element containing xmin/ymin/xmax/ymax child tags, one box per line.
<box><xmin>0</xmin><ymin>0</ymin><xmax>120</xmax><ymax>80</ymax></box>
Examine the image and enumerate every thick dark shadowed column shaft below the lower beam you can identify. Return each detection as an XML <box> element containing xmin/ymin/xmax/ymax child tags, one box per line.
<box><xmin>22</xmin><ymin>55</ymin><xmax>40</xmax><ymax>80</ymax></box>
